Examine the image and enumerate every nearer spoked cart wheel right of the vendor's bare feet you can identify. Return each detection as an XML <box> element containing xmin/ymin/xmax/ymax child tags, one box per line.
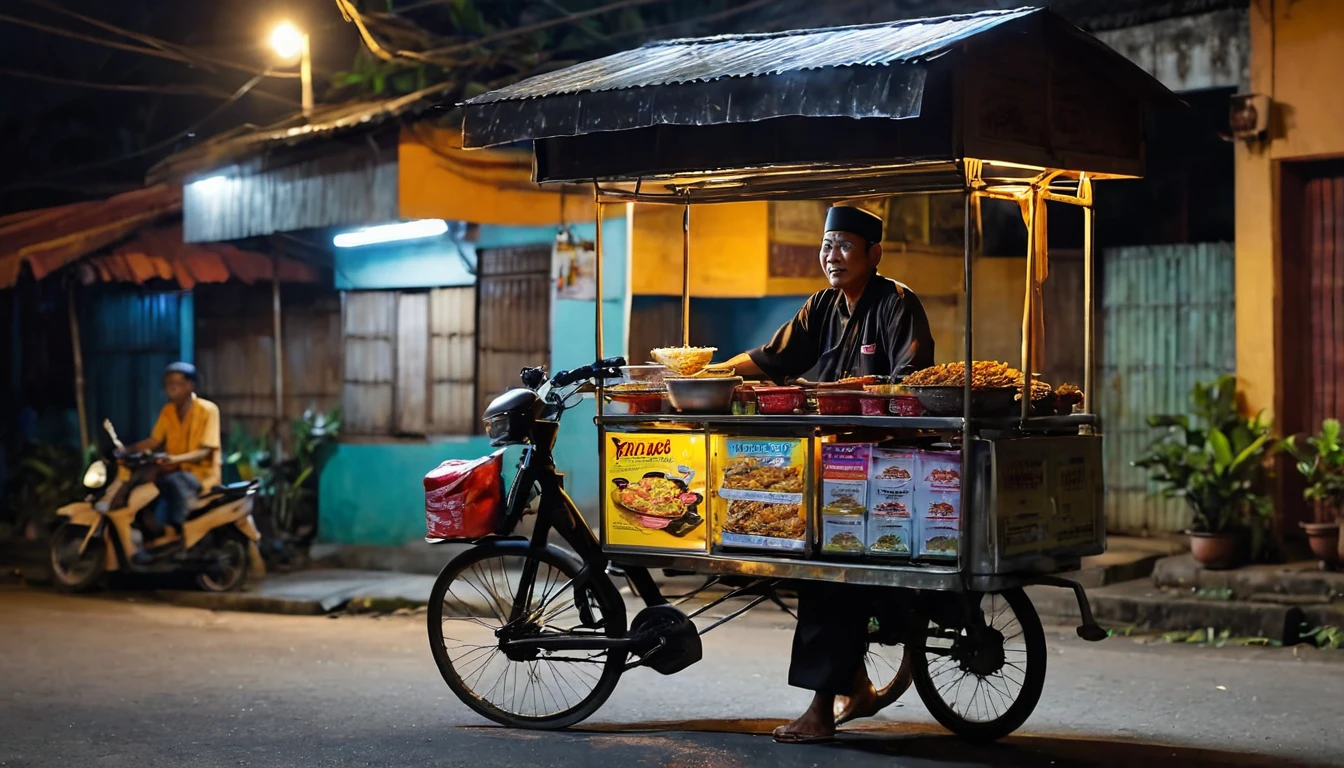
<box><xmin>910</xmin><ymin>589</ymin><xmax>1046</xmax><ymax>741</ymax></box>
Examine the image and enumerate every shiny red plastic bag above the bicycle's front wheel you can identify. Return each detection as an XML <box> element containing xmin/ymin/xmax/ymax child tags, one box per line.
<box><xmin>425</xmin><ymin>451</ymin><xmax>504</xmax><ymax>541</ymax></box>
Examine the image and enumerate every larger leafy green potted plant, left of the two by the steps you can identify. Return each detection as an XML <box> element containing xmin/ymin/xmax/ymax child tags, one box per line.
<box><xmin>1134</xmin><ymin>375</ymin><xmax>1274</xmax><ymax>569</ymax></box>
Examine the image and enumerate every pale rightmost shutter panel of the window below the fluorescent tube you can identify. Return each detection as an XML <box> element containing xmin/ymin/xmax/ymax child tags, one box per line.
<box><xmin>429</xmin><ymin>286</ymin><xmax>480</xmax><ymax>434</ymax></box>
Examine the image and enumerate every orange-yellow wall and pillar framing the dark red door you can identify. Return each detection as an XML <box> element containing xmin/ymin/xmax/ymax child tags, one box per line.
<box><xmin>1236</xmin><ymin>0</ymin><xmax>1344</xmax><ymax>413</ymax></box>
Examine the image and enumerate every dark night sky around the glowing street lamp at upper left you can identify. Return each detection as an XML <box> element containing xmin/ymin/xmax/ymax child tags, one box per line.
<box><xmin>0</xmin><ymin>0</ymin><xmax>359</xmax><ymax>211</ymax></box>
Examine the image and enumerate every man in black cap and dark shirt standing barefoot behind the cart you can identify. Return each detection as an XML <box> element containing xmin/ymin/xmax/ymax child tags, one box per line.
<box><xmin>724</xmin><ymin>206</ymin><xmax>934</xmax><ymax>744</ymax></box>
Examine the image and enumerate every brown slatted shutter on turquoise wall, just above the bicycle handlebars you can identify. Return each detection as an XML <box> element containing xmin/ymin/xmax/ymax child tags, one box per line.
<box><xmin>476</xmin><ymin>246</ymin><xmax>551</xmax><ymax>413</ymax></box>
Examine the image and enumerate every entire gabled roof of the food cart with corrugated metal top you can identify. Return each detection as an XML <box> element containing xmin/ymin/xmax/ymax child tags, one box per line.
<box><xmin>464</xmin><ymin>8</ymin><xmax>1179</xmax><ymax>199</ymax></box>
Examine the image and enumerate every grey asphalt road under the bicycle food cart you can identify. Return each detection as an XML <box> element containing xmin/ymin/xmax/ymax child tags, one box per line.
<box><xmin>0</xmin><ymin>586</ymin><xmax>1344</xmax><ymax>768</ymax></box>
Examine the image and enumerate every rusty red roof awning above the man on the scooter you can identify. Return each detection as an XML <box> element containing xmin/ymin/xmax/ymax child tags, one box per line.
<box><xmin>0</xmin><ymin>184</ymin><xmax>319</xmax><ymax>289</ymax></box>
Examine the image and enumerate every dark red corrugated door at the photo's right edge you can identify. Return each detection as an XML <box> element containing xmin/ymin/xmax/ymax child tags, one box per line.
<box><xmin>1304</xmin><ymin>176</ymin><xmax>1344</xmax><ymax>522</ymax></box>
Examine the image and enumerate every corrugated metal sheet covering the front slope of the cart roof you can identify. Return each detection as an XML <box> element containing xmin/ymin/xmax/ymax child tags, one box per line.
<box><xmin>464</xmin><ymin>8</ymin><xmax>1040</xmax><ymax>147</ymax></box>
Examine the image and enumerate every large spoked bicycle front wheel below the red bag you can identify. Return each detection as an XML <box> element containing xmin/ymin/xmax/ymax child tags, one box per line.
<box><xmin>429</xmin><ymin>542</ymin><xmax>626</xmax><ymax>729</ymax></box>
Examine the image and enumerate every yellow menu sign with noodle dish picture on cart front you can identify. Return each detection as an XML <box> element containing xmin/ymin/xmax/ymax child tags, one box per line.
<box><xmin>602</xmin><ymin>433</ymin><xmax>706</xmax><ymax>551</ymax></box>
